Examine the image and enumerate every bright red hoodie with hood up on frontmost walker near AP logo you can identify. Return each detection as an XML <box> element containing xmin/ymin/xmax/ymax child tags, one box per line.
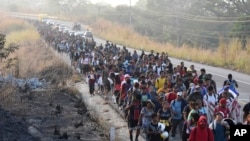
<box><xmin>188</xmin><ymin>116</ymin><xmax>214</xmax><ymax>141</ymax></box>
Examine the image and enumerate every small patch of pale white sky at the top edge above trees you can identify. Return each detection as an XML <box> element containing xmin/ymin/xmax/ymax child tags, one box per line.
<box><xmin>90</xmin><ymin>0</ymin><xmax>138</xmax><ymax>7</ymax></box>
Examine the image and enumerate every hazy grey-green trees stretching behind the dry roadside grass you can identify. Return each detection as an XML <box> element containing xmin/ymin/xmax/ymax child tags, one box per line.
<box><xmin>0</xmin><ymin>0</ymin><xmax>250</xmax><ymax>48</ymax></box>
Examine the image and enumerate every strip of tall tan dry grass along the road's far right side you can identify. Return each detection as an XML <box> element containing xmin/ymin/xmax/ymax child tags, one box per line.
<box><xmin>91</xmin><ymin>19</ymin><xmax>250</xmax><ymax>74</ymax></box>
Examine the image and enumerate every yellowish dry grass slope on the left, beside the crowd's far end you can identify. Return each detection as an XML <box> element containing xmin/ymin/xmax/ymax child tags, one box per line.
<box><xmin>0</xmin><ymin>14</ymin><xmax>72</xmax><ymax>83</ymax></box>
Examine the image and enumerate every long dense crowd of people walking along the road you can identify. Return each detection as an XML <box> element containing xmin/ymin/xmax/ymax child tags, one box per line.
<box><xmin>31</xmin><ymin>19</ymin><xmax>250</xmax><ymax>141</ymax></box>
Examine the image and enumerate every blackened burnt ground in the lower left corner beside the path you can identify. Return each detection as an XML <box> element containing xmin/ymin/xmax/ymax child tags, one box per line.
<box><xmin>0</xmin><ymin>88</ymin><xmax>108</xmax><ymax>141</ymax></box>
